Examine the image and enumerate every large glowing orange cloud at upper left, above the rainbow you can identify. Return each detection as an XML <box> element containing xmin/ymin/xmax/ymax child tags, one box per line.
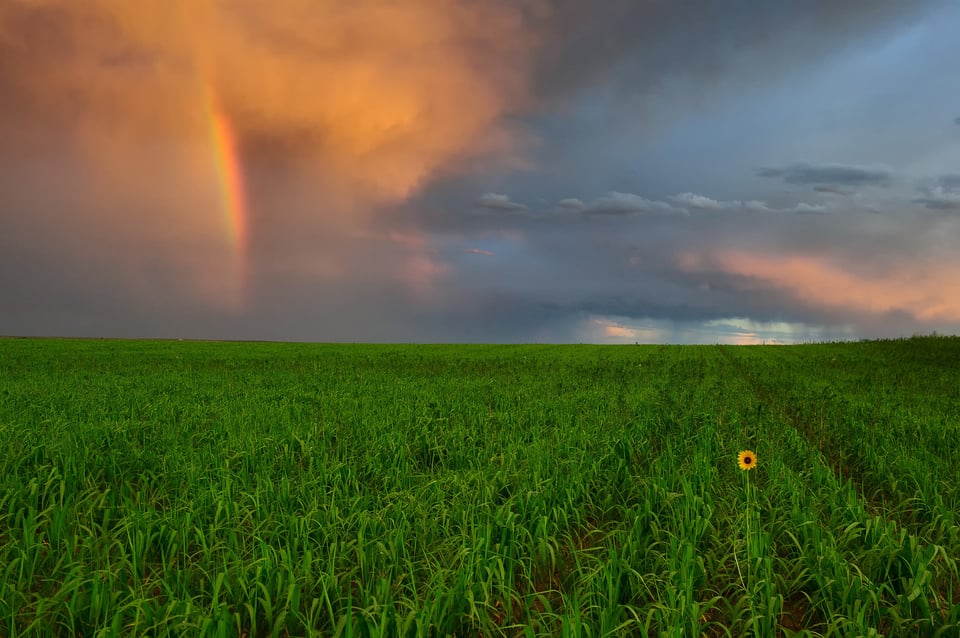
<box><xmin>3</xmin><ymin>0</ymin><xmax>534</xmax><ymax>197</ymax></box>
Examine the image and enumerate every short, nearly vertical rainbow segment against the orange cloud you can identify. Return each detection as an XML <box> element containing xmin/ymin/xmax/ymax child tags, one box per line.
<box><xmin>204</xmin><ymin>84</ymin><xmax>249</xmax><ymax>306</ymax></box>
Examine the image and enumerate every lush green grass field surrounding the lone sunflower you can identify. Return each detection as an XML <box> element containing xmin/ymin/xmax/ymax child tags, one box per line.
<box><xmin>0</xmin><ymin>337</ymin><xmax>960</xmax><ymax>637</ymax></box>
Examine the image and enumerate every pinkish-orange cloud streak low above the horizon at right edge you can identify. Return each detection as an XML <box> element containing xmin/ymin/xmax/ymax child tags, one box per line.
<box><xmin>678</xmin><ymin>250</ymin><xmax>960</xmax><ymax>322</ymax></box>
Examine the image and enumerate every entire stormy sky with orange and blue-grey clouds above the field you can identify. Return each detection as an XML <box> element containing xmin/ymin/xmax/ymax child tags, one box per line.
<box><xmin>0</xmin><ymin>0</ymin><xmax>960</xmax><ymax>344</ymax></box>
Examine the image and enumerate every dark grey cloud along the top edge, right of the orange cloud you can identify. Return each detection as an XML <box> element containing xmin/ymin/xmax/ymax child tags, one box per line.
<box><xmin>531</xmin><ymin>0</ymin><xmax>937</xmax><ymax>99</ymax></box>
